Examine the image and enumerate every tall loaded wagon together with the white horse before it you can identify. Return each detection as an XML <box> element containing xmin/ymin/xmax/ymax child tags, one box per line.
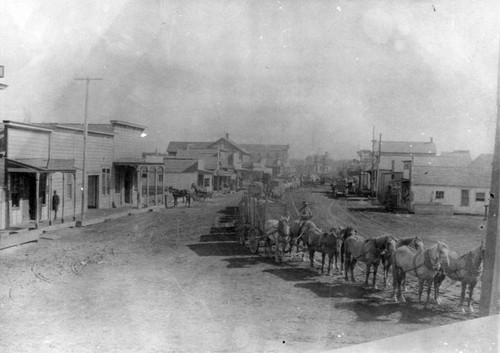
<box><xmin>237</xmin><ymin>193</ymin><xmax>289</xmax><ymax>257</ymax></box>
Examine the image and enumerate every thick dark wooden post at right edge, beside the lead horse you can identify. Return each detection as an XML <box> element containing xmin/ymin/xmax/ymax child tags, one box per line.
<box><xmin>479</xmin><ymin>45</ymin><xmax>500</xmax><ymax>316</ymax></box>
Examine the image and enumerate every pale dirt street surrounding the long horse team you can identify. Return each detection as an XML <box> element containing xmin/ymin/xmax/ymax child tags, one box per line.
<box><xmin>0</xmin><ymin>189</ymin><xmax>492</xmax><ymax>352</ymax></box>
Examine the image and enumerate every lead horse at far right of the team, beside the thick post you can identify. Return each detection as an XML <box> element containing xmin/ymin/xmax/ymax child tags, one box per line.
<box><xmin>434</xmin><ymin>242</ymin><xmax>485</xmax><ymax>312</ymax></box>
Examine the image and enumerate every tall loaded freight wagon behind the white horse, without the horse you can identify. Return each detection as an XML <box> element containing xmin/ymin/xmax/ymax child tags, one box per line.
<box><xmin>236</xmin><ymin>193</ymin><xmax>286</xmax><ymax>254</ymax></box>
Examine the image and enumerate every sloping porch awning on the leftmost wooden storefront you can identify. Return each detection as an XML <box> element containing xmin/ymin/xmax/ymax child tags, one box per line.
<box><xmin>6</xmin><ymin>158</ymin><xmax>76</xmax><ymax>173</ymax></box>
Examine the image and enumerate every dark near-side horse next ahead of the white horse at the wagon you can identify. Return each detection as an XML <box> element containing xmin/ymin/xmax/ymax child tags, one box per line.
<box><xmin>301</xmin><ymin>221</ymin><xmax>339</xmax><ymax>275</ymax></box>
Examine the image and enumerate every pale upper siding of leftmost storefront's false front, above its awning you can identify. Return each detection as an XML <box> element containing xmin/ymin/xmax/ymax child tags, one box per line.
<box><xmin>7</xmin><ymin>128</ymin><xmax>50</xmax><ymax>159</ymax></box>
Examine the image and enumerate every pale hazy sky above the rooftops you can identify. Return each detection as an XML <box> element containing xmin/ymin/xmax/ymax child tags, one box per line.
<box><xmin>0</xmin><ymin>0</ymin><xmax>500</xmax><ymax>158</ymax></box>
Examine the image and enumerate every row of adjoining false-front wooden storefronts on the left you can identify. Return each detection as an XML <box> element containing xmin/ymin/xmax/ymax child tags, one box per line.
<box><xmin>0</xmin><ymin>120</ymin><xmax>164</xmax><ymax>229</ymax></box>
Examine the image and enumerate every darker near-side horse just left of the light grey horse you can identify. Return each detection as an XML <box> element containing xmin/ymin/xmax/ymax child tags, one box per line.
<box><xmin>344</xmin><ymin>235</ymin><xmax>396</xmax><ymax>289</ymax></box>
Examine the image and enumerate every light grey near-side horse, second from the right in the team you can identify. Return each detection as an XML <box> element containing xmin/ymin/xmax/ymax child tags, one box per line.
<box><xmin>392</xmin><ymin>241</ymin><xmax>450</xmax><ymax>306</ymax></box>
